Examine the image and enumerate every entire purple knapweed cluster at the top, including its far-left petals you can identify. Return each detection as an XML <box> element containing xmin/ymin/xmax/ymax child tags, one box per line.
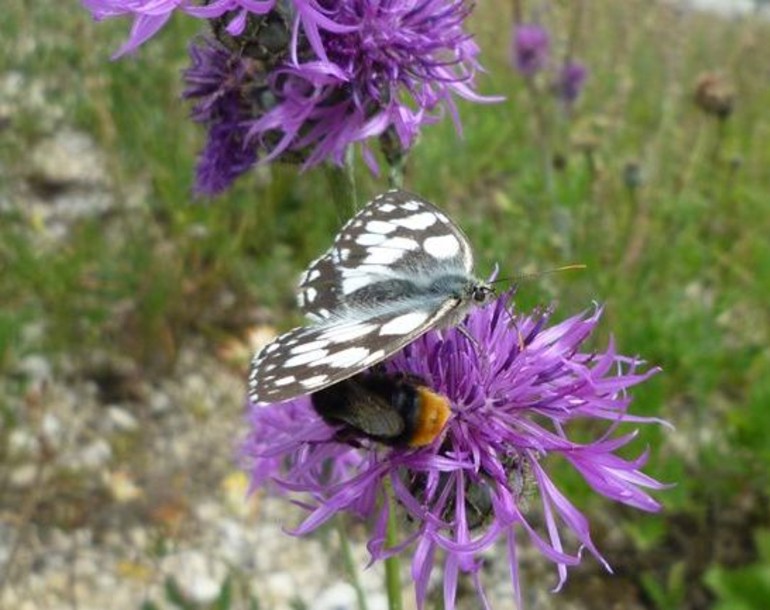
<box><xmin>83</xmin><ymin>0</ymin><xmax>500</xmax><ymax>194</ymax></box>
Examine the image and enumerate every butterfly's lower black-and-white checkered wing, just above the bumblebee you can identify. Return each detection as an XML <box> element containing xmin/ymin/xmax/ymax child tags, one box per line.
<box><xmin>249</xmin><ymin>299</ymin><xmax>455</xmax><ymax>404</ymax></box>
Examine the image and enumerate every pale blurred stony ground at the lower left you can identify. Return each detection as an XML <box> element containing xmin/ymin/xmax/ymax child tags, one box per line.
<box><xmin>0</xmin><ymin>332</ymin><xmax>642</xmax><ymax>610</ymax></box>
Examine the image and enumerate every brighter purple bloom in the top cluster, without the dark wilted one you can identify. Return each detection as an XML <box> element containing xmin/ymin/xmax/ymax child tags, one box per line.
<box><xmin>244</xmin><ymin>0</ymin><xmax>497</xmax><ymax>172</ymax></box>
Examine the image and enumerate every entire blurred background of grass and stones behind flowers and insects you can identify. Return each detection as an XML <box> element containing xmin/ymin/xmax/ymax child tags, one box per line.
<box><xmin>0</xmin><ymin>0</ymin><xmax>770</xmax><ymax>610</ymax></box>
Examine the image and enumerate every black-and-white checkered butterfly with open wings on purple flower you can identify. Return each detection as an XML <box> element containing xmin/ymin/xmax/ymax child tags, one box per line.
<box><xmin>249</xmin><ymin>189</ymin><xmax>494</xmax><ymax>404</ymax></box>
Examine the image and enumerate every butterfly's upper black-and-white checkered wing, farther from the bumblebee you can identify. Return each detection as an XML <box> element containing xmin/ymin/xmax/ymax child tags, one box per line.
<box><xmin>297</xmin><ymin>190</ymin><xmax>473</xmax><ymax>322</ymax></box>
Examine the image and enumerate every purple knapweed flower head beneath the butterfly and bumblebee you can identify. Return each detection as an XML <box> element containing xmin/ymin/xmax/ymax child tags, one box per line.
<box><xmin>242</xmin><ymin>295</ymin><xmax>663</xmax><ymax>610</ymax></box>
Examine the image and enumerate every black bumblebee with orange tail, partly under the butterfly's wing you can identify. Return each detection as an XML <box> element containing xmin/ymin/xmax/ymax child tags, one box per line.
<box><xmin>311</xmin><ymin>372</ymin><xmax>451</xmax><ymax>447</ymax></box>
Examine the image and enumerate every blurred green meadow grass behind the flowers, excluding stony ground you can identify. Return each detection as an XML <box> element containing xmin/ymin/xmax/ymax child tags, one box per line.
<box><xmin>0</xmin><ymin>0</ymin><xmax>770</xmax><ymax>597</ymax></box>
